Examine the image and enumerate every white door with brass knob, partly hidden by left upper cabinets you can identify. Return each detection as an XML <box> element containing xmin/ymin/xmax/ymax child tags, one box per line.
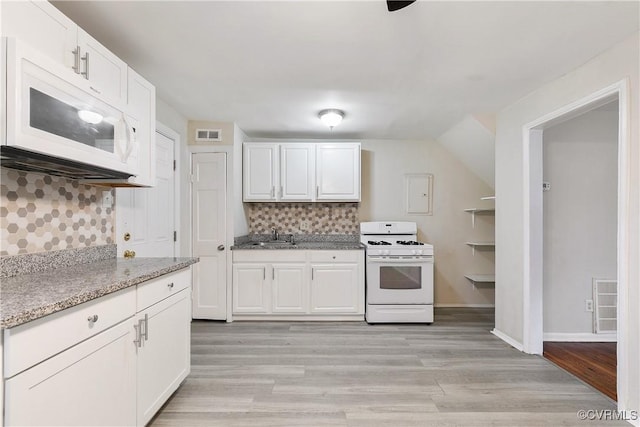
<box><xmin>116</xmin><ymin>132</ymin><xmax>176</xmax><ymax>257</ymax></box>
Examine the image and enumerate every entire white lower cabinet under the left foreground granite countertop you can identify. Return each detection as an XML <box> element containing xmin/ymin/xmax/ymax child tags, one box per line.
<box><xmin>3</xmin><ymin>270</ymin><xmax>191</xmax><ymax>426</ymax></box>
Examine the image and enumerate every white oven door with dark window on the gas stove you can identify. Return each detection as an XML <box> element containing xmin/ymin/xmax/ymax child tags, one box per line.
<box><xmin>367</xmin><ymin>256</ymin><xmax>433</xmax><ymax>304</ymax></box>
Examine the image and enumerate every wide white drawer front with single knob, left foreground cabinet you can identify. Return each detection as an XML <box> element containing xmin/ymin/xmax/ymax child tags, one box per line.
<box><xmin>4</xmin><ymin>287</ymin><xmax>136</xmax><ymax>378</ymax></box>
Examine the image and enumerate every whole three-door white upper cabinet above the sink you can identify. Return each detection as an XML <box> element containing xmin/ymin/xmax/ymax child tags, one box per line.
<box><xmin>243</xmin><ymin>142</ymin><xmax>360</xmax><ymax>202</ymax></box>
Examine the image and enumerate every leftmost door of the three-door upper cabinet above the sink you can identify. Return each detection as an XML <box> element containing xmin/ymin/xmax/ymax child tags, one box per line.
<box><xmin>242</xmin><ymin>143</ymin><xmax>279</xmax><ymax>202</ymax></box>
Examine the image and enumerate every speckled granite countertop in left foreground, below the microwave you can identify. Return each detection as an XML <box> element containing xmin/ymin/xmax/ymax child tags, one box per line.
<box><xmin>0</xmin><ymin>258</ymin><xmax>198</xmax><ymax>329</ymax></box>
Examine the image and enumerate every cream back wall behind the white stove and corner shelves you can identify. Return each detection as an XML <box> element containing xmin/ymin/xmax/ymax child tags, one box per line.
<box><xmin>360</xmin><ymin>140</ymin><xmax>494</xmax><ymax>306</ymax></box>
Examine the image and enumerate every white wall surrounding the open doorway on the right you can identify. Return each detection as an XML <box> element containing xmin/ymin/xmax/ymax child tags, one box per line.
<box><xmin>496</xmin><ymin>34</ymin><xmax>640</xmax><ymax>423</ymax></box>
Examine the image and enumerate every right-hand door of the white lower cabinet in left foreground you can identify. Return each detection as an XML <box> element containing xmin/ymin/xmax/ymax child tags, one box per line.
<box><xmin>136</xmin><ymin>289</ymin><xmax>191</xmax><ymax>426</ymax></box>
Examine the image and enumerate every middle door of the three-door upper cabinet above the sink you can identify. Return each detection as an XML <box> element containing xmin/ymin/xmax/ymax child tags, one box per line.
<box><xmin>278</xmin><ymin>143</ymin><xmax>315</xmax><ymax>202</ymax></box>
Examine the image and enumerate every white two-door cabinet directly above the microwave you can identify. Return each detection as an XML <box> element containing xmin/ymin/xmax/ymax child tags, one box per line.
<box><xmin>1</xmin><ymin>1</ymin><xmax>127</xmax><ymax>105</ymax></box>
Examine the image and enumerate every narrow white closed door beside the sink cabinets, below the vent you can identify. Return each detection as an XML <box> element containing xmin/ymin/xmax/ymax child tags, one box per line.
<box><xmin>191</xmin><ymin>153</ymin><xmax>228</xmax><ymax>320</ymax></box>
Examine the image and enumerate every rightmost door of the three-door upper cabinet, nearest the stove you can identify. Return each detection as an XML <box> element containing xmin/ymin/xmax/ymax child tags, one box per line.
<box><xmin>316</xmin><ymin>143</ymin><xmax>360</xmax><ymax>201</ymax></box>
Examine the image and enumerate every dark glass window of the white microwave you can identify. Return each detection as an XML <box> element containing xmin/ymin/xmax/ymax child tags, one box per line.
<box><xmin>29</xmin><ymin>88</ymin><xmax>115</xmax><ymax>153</ymax></box>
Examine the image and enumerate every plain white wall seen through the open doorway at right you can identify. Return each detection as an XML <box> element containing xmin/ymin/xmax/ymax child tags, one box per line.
<box><xmin>543</xmin><ymin>103</ymin><xmax>618</xmax><ymax>334</ymax></box>
